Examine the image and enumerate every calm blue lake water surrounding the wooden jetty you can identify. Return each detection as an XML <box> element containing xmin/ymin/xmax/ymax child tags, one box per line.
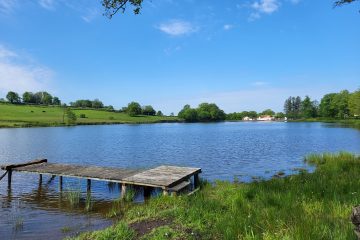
<box><xmin>0</xmin><ymin>123</ymin><xmax>360</xmax><ymax>239</ymax></box>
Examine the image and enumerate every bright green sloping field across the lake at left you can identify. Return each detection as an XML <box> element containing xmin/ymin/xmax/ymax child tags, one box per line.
<box><xmin>0</xmin><ymin>104</ymin><xmax>178</xmax><ymax>127</ymax></box>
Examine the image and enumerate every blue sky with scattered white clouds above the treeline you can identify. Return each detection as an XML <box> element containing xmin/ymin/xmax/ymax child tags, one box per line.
<box><xmin>0</xmin><ymin>0</ymin><xmax>360</xmax><ymax>114</ymax></box>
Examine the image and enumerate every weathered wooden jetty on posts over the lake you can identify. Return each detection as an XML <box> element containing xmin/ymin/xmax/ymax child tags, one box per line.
<box><xmin>1</xmin><ymin>159</ymin><xmax>201</xmax><ymax>197</ymax></box>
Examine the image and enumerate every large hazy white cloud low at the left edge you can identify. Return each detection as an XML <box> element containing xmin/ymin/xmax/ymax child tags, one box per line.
<box><xmin>0</xmin><ymin>45</ymin><xmax>53</xmax><ymax>93</ymax></box>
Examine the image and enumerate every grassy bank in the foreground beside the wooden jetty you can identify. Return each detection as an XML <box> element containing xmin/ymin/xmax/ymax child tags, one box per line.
<box><xmin>74</xmin><ymin>153</ymin><xmax>360</xmax><ymax>240</ymax></box>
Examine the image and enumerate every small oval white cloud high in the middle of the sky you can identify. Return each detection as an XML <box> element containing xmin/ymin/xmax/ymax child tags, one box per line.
<box><xmin>157</xmin><ymin>19</ymin><xmax>198</xmax><ymax>36</ymax></box>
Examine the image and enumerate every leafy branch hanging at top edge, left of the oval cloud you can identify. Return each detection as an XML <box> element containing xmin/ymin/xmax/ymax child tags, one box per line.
<box><xmin>102</xmin><ymin>0</ymin><xmax>143</xmax><ymax>18</ymax></box>
